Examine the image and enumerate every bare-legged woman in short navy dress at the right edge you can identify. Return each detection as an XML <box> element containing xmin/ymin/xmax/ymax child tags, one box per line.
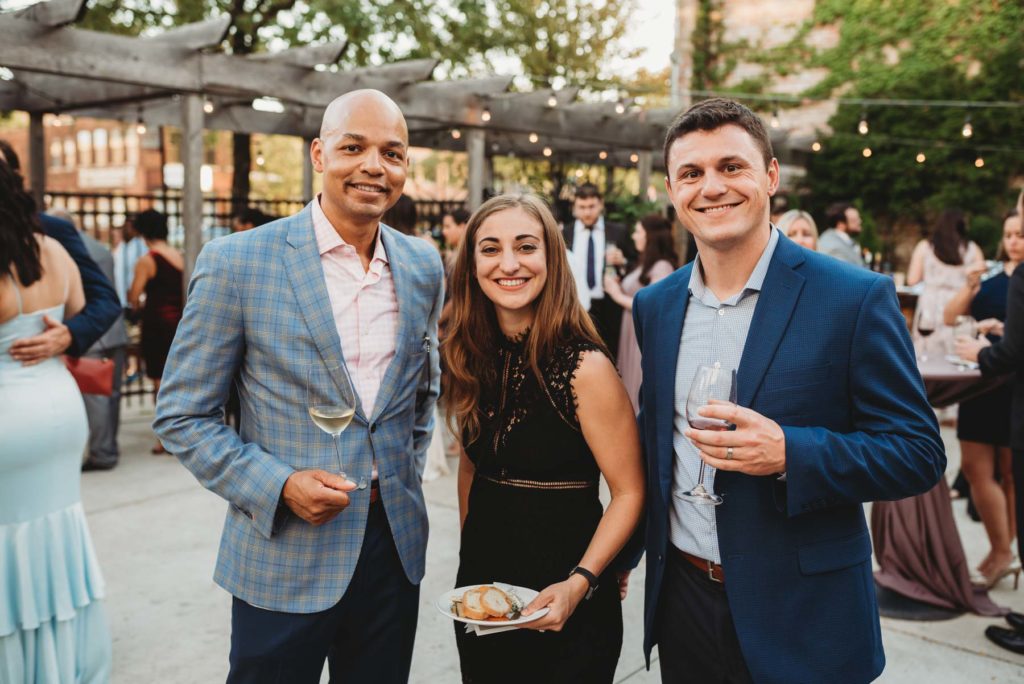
<box><xmin>945</xmin><ymin>210</ymin><xmax>1024</xmax><ymax>587</ymax></box>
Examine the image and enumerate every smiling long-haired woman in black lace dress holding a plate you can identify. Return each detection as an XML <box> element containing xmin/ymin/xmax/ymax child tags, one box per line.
<box><xmin>442</xmin><ymin>196</ymin><xmax>644</xmax><ymax>684</ymax></box>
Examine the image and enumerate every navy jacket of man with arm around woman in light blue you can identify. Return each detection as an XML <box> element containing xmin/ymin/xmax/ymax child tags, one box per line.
<box><xmin>39</xmin><ymin>214</ymin><xmax>121</xmax><ymax>356</ymax></box>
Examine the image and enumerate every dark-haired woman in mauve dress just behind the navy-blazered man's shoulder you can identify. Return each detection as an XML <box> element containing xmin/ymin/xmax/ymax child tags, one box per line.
<box><xmin>604</xmin><ymin>214</ymin><xmax>679</xmax><ymax>413</ymax></box>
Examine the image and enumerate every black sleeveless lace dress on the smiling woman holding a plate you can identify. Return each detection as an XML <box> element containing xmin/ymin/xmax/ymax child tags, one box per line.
<box><xmin>456</xmin><ymin>331</ymin><xmax>623</xmax><ymax>684</ymax></box>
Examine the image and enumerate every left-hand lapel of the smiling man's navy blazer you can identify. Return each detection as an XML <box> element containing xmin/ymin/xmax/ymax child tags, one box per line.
<box><xmin>654</xmin><ymin>262</ymin><xmax>693</xmax><ymax>501</ymax></box>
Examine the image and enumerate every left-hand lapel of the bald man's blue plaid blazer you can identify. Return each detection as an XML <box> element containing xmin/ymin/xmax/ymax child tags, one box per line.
<box><xmin>285</xmin><ymin>200</ymin><xmax>366</xmax><ymax>420</ymax></box>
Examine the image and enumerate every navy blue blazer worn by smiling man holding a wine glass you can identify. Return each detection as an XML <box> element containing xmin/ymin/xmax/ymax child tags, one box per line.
<box><xmin>633</xmin><ymin>237</ymin><xmax>946</xmax><ymax>684</ymax></box>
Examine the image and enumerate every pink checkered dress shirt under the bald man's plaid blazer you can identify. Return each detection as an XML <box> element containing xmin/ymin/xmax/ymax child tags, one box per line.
<box><xmin>313</xmin><ymin>197</ymin><xmax>398</xmax><ymax>417</ymax></box>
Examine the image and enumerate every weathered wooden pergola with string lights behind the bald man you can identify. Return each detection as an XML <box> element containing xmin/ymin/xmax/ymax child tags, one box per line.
<box><xmin>0</xmin><ymin>0</ymin><xmax>672</xmax><ymax>281</ymax></box>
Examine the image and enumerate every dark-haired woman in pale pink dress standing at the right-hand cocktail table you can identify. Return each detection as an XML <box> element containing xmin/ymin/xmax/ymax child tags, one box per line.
<box><xmin>906</xmin><ymin>209</ymin><xmax>985</xmax><ymax>356</ymax></box>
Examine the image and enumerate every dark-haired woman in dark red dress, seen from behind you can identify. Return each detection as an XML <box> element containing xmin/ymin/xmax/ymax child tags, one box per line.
<box><xmin>128</xmin><ymin>209</ymin><xmax>184</xmax><ymax>454</ymax></box>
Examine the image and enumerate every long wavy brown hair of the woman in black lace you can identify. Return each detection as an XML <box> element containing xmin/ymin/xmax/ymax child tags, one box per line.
<box><xmin>441</xmin><ymin>195</ymin><xmax>605</xmax><ymax>441</ymax></box>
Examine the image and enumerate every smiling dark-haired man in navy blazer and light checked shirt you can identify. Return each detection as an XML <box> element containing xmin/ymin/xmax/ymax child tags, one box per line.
<box><xmin>633</xmin><ymin>99</ymin><xmax>945</xmax><ymax>684</ymax></box>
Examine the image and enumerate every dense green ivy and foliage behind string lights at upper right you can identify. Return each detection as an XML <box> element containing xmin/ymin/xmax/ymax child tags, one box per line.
<box><xmin>763</xmin><ymin>0</ymin><xmax>1024</xmax><ymax>260</ymax></box>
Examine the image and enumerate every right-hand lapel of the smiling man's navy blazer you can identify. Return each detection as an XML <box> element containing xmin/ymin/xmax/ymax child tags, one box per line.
<box><xmin>736</xmin><ymin>236</ymin><xmax>805</xmax><ymax>407</ymax></box>
